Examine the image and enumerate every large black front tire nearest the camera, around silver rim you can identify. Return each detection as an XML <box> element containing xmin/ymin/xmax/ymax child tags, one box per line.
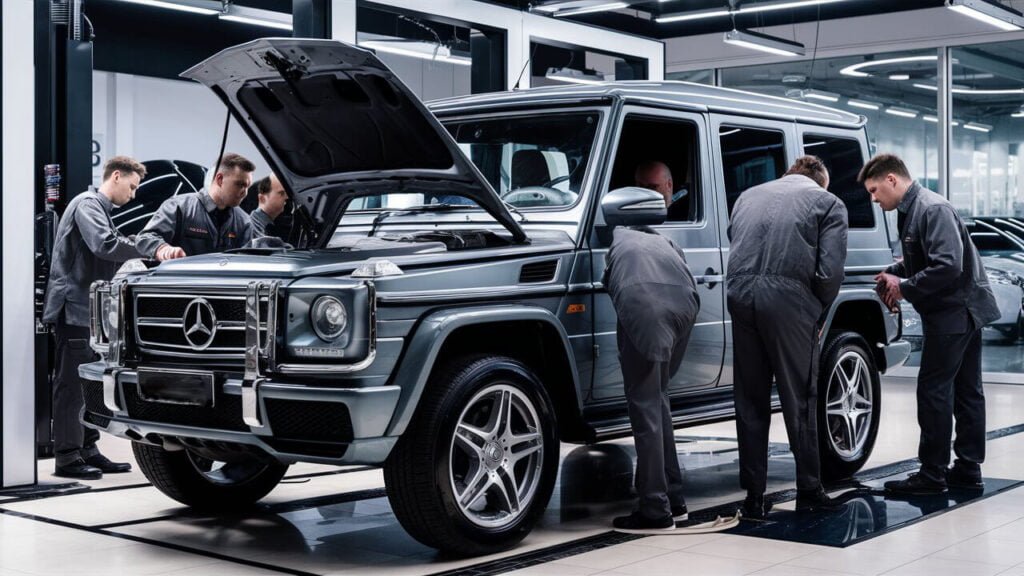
<box><xmin>384</xmin><ymin>356</ymin><xmax>558</xmax><ymax>556</ymax></box>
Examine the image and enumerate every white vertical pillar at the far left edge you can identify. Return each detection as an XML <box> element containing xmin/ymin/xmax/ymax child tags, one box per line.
<box><xmin>0</xmin><ymin>0</ymin><xmax>41</xmax><ymax>488</ymax></box>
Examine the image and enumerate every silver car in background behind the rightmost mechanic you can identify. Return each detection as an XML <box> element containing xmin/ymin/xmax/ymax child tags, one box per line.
<box><xmin>901</xmin><ymin>218</ymin><xmax>1024</xmax><ymax>344</ymax></box>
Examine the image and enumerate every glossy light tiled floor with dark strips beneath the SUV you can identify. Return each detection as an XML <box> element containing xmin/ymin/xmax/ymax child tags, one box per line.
<box><xmin>6</xmin><ymin>379</ymin><xmax>1024</xmax><ymax>576</ymax></box>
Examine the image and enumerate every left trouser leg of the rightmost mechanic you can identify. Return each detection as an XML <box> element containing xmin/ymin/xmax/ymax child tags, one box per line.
<box><xmin>918</xmin><ymin>331</ymin><xmax>970</xmax><ymax>482</ymax></box>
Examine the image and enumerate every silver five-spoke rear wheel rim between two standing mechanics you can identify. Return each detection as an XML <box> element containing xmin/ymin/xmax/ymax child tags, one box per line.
<box><xmin>825</xmin><ymin>351</ymin><xmax>874</xmax><ymax>461</ymax></box>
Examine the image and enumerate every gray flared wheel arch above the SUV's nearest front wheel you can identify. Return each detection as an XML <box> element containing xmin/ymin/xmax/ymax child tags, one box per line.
<box><xmin>386</xmin><ymin>305</ymin><xmax>592</xmax><ymax>441</ymax></box>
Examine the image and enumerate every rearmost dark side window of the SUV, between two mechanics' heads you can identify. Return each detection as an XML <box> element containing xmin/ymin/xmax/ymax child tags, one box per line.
<box><xmin>804</xmin><ymin>134</ymin><xmax>874</xmax><ymax>229</ymax></box>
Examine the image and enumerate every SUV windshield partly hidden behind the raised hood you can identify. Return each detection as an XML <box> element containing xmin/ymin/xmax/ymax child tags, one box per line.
<box><xmin>349</xmin><ymin>112</ymin><xmax>599</xmax><ymax>210</ymax></box>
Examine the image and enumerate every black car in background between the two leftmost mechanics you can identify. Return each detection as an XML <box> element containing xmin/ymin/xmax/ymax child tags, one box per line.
<box><xmin>111</xmin><ymin>160</ymin><xmax>206</xmax><ymax>236</ymax></box>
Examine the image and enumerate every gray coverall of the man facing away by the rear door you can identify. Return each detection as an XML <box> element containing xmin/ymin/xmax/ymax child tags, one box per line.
<box><xmin>726</xmin><ymin>174</ymin><xmax>848</xmax><ymax>494</ymax></box>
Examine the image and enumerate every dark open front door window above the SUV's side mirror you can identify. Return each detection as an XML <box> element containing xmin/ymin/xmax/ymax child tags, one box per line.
<box><xmin>608</xmin><ymin>115</ymin><xmax>703</xmax><ymax>222</ymax></box>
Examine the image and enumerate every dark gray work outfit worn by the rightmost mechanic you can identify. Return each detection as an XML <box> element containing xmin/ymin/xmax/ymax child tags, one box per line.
<box><xmin>886</xmin><ymin>182</ymin><xmax>999</xmax><ymax>483</ymax></box>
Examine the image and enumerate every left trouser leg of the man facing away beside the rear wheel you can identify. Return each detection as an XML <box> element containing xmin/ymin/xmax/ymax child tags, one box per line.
<box><xmin>732</xmin><ymin>314</ymin><xmax>772</xmax><ymax>494</ymax></box>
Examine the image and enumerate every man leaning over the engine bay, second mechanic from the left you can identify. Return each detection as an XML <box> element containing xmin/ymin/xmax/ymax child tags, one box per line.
<box><xmin>135</xmin><ymin>153</ymin><xmax>256</xmax><ymax>261</ymax></box>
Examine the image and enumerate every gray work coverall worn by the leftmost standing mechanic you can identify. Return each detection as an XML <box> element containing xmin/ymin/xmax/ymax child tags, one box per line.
<box><xmin>43</xmin><ymin>189</ymin><xmax>141</xmax><ymax>466</ymax></box>
